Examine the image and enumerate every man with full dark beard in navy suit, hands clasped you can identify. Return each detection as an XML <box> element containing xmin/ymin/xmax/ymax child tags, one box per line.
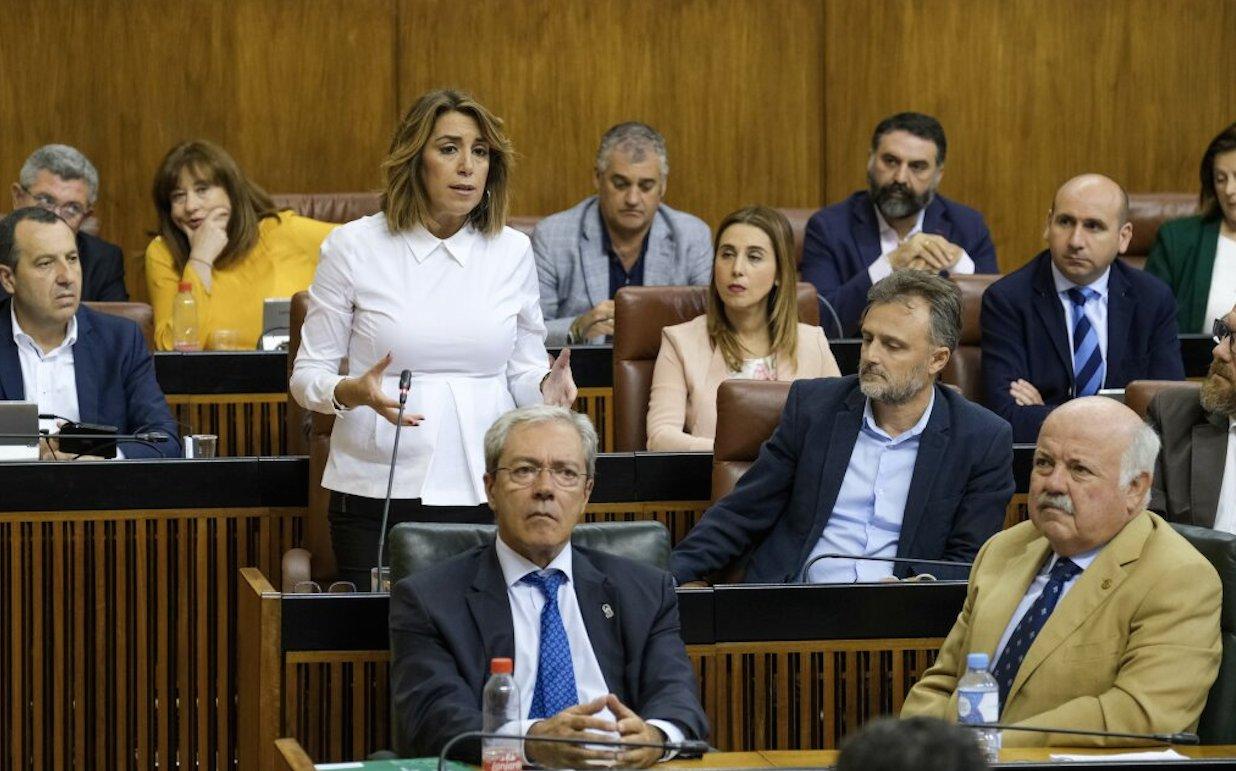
<box><xmin>802</xmin><ymin>112</ymin><xmax>1000</xmax><ymax>336</ymax></box>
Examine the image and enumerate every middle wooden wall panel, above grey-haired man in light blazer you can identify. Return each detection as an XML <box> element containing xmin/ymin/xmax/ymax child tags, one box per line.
<box><xmin>398</xmin><ymin>0</ymin><xmax>823</xmax><ymax>232</ymax></box>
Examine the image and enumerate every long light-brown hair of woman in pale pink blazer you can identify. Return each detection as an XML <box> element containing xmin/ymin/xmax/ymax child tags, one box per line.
<box><xmin>708</xmin><ymin>206</ymin><xmax>798</xmax><ymax>372</ymax></box>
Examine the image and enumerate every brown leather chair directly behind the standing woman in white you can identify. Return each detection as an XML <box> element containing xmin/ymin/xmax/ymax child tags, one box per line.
<box><xmin>283</xmin><ymin>292</ymin><xmax>336</xmax><ymax>583</ymax></box>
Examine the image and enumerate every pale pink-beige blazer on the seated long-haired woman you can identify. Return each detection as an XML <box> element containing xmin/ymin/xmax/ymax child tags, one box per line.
<box><xmin>648</xmin><ymin>315</ymin><xmax>840</xmax><ymax>452</ymax></box>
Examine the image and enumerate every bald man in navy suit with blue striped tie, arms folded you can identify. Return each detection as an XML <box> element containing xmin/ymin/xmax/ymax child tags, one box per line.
<box><xmin>980</xmin><ymin>174</ymin><xmax>1184</xmax><ymax>442</ymax></box>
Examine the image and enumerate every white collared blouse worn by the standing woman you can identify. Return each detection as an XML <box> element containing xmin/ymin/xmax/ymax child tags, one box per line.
<box><xmin>290</xmin><ymin>214</ymin><xmax>549</xmax><ymax>505</ymax></box>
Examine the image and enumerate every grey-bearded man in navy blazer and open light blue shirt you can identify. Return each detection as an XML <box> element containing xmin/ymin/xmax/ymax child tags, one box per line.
<box><xmin>670</xmin><ymin>271</ymin><xmax>1014</xmax><ymax>584</ymax></box>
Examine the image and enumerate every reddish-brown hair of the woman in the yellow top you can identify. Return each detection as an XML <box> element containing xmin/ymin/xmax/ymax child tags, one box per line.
<box><xmin>153</xmin><ymin>140</ymin><xmax>279</xmax><ymax>271</ymax></box>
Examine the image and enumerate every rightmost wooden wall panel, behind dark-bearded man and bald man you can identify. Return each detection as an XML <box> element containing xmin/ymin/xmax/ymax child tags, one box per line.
<box><xmin>823</xmin><ymin>0</ymin><xmax>1236</xmax><ymax>271</ymax></box>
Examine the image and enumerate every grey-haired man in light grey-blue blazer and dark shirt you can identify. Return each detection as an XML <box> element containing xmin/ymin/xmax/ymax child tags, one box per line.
<box><xmin>533</xmin><ymin>122</ymin><xmax>712</xmax><ymax>345</ymax></box>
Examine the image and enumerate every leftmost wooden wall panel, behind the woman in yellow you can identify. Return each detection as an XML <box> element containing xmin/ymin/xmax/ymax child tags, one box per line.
<box><xmin>0</xmin><ymin>0</ymin><xmax>396</xmax><ymax>299</ymax></box>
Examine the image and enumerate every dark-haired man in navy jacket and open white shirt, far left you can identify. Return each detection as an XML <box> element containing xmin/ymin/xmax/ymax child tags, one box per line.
<box><xmin>0</xmin><ymin>206</ymin><xmax>180</xmax><ymax>460</ymax></box>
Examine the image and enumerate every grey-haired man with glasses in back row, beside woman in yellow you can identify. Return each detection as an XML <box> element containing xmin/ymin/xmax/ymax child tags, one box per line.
<box><xmin>8</xmin><ymin>145</ymin><xmax>129</xmax><ymax>301</ymax></box>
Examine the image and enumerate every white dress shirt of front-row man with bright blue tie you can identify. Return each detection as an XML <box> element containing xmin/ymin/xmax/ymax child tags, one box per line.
<box><xmin>497</xmin><ymin>537</ymin><xmax>685</xmax><ymax>749</ymax></box>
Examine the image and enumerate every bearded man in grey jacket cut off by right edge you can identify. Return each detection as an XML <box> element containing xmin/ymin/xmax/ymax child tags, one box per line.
<box><xmin>1146</xmin><ymin>301</ymin><xmax>1236</xmax><ymax>533</ymax></box>
